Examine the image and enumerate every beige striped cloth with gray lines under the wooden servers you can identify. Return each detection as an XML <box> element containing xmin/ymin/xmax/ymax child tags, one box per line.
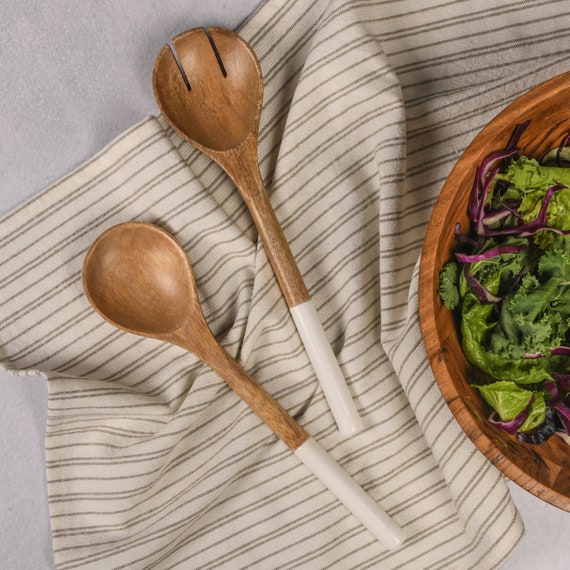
<box><xmin>0</xmin><ymin>0</ymin><xmax>570</xmax><ymax>570</ymax></box>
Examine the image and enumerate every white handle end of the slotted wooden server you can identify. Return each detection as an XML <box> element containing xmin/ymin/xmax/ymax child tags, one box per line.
<box><xmin>290</xmin><ymin>300</ymin><xmax>362</xmax><ymax>435</ymax></box>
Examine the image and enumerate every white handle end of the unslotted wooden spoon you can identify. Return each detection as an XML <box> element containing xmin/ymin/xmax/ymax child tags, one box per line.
<box><xmin>294</xmin><ymin>437</ymin><xmax>405</xmax><ymax>550</ymax></box>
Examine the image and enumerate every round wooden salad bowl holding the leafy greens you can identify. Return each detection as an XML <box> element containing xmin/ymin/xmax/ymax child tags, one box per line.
<box><xmin>419</xmin><ymin>72</ymin><xmax>570</xmax><ymax>511</ymax></box>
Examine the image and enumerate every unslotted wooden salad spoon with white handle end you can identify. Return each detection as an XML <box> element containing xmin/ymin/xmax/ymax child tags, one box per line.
<box><xmin>83</xmin><ymin>222</ymin><xmax>404</xmax><ymax>549</ymax></box>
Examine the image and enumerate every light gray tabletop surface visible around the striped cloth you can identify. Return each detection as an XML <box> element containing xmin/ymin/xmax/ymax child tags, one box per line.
<box><xmin>0</xmin><ymin>0</ymin><xmax>570</xmax><ymax>570</ymax></box>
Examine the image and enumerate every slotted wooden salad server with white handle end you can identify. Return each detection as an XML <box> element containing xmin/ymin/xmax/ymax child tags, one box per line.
<box><xmin>153</xmin><ymin>27</ymin><xmax>362</xmax><ymax>435</ymax></box>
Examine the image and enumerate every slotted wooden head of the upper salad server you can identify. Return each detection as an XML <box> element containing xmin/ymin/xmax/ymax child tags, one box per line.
<box><xmin>154</xmin><ymin>28</ymin><xmax>263</xmax><ymax>152</ymax></box>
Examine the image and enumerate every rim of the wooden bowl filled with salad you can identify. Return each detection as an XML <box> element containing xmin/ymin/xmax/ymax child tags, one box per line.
<box><xmin>418</xmin><ymin>71</ymin><xmax>570</xmax><ymax>512</ymax></box>
